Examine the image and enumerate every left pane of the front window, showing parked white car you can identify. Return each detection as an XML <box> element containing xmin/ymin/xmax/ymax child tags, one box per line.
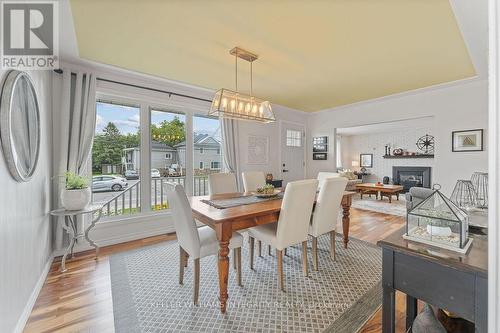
<box><xmin>92</xmin><ymin>102</ymin><xmax>141</xmax><ymax>219</ymax></box>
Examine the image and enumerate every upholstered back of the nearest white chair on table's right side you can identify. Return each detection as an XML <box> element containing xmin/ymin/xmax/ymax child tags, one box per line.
<box><xmin>276</xmin><ymin>179</ymin><xmax>318</xmax><ymax>250</ymax></box>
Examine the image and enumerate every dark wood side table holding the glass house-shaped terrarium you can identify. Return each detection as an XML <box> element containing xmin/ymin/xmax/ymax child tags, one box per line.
<box><xmin>377</xmin><ymin>228</ymin><xmax>488</xmax><ymax>333</ymax></box>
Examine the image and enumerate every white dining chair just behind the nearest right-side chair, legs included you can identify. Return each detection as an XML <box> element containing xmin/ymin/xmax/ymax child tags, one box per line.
<box><xmin>309</xmin><ymin>177</ymin><xmax>347</xmax><ymax>271</ymax></box>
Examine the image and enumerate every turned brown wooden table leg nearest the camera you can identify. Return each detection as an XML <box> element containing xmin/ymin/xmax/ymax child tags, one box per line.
<box><xmin>216</xmin><ymin>223</ymin><xmax>233</xmax><ymax>313</ymax></box>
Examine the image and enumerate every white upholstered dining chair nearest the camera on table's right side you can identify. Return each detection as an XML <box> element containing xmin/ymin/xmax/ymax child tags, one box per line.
<box><xmin>248</xmin><ymin>179</ymin><xmax>318</xmax><ymax>291</ymax></box>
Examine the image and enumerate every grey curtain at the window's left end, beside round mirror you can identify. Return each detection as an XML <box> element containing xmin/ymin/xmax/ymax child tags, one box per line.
<box><xmin>53</xmin><ymin>69</ymin><xmax>96</xmax><ymax>249</ymax></box>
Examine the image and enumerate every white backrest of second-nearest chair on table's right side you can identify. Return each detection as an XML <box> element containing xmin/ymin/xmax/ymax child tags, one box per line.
<box><xmin>310</xmin><ymin>177</ymin><xmax>347</xmax><ymax>237</ymax></box>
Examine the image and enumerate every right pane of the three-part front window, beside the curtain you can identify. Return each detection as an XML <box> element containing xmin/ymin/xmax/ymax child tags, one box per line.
<box><xmin>193</xmin><ymin>116</ymin><xmax>222</xmax><ymax>195</ymax></box>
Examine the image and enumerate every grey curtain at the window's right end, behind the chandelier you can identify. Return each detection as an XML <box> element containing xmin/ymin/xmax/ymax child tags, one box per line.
<box><xmin>220</xmin><ymin>118</ymin><xmax>241</xmax><ymax>189</ymax></box>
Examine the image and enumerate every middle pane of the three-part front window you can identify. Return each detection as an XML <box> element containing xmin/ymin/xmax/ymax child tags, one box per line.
<box><xmin>150</xmin><ymin>110</ymin><xmax>186</xmax><ymax>210</ymax></box>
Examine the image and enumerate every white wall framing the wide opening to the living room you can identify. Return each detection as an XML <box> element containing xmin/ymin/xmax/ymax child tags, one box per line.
<box><xmin>308</xmin><ymin>79</ymin><xmax>488</xmax><ymax>194</ymax></box>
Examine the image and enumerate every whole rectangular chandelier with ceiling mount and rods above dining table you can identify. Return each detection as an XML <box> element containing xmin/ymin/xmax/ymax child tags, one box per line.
<box><xmin>208</xmin><ymin>47</ymin><xmax>276</xmax><ymax>123</ymax></box>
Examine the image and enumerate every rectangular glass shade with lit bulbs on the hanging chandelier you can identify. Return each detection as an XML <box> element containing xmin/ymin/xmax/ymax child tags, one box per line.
<box><xmin>208</xmin><ymin>89</ymin><xmax>276</xmax><ymax>123</ymax></box>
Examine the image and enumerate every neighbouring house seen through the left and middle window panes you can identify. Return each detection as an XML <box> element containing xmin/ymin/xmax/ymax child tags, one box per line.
<box><xmin>122</xmin><ymin>141</ymin><xmax>178</xmax><ymax>171</ymax></box>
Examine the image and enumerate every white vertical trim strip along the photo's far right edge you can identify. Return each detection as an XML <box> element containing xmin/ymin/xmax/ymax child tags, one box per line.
<box><xmin>488</xmin><ymin>0</ymin><xmax>500</xmax><ymax>332</ymax></box>
